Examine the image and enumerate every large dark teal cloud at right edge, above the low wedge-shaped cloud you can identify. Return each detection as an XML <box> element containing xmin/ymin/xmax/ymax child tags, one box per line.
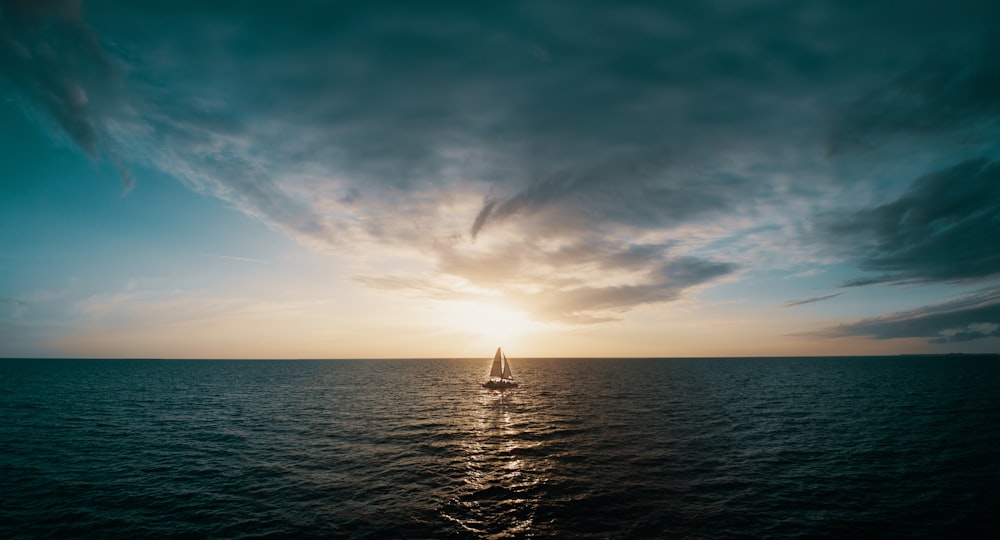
<box><xmin>821</xmin><ymin>160</ymin><xmax>1000</xmax><ymax>286</ymax></box>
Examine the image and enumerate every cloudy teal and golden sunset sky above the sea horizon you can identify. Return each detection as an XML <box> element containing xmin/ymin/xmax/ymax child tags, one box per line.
<box><xmin>0</xmin><ymin>0</ymin><xmax>1000</xmax><ymax>358</ymax></box>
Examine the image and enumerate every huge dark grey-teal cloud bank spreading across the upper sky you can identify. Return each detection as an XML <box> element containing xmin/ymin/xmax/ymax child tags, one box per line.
<box><xmin>7</xmin><ymin>1</ymin><xmax>998</xmax><ymax>319</ymax></box>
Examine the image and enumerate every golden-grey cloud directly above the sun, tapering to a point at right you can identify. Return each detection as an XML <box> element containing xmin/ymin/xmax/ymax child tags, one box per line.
<box><xmin>359</xmin><ymin>239</ymin><xmax>738</xmax><ymax>324</ymax></box>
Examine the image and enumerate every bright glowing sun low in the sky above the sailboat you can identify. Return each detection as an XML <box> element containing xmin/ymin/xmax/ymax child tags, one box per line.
<box><xmin>441</xmin><ymin>301</ymin><xmax>539</xmax><ymax>347</ymax></box>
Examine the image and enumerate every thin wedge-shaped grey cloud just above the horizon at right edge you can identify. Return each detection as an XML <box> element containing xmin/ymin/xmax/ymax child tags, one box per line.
<box><xmin>818</xmin><ymin>288</ymin><xmax>1000</xmax><ymax>344</ymax></box>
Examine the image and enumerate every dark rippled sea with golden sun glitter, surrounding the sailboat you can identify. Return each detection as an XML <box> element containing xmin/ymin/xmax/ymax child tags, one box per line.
<box><xmin>0</xmin><ymin>356</ymin><xmax>1000</xmax><ymax>538</ymax></box>
